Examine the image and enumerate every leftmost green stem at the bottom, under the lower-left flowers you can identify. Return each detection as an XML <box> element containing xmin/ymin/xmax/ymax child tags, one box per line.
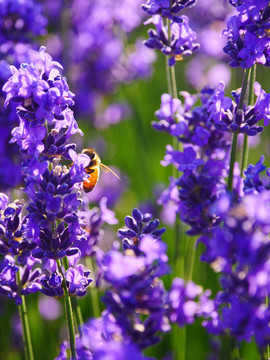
<box><xmin>16</xmin><ymin>271</ymin><xmax>34</xmax><ymax>360</ymax></box>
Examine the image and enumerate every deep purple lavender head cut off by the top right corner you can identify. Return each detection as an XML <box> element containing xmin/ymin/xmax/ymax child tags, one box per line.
<box><xmin>224</xmin><ymin>0</ymin><xmax>270</xmax><ymax>68</ymax></box>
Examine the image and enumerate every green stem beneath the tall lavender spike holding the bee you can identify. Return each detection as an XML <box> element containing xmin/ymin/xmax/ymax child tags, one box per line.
<box><xmin>57</xmin><ymin>259</ymin><xmax>77</xmax><ymax>360</ymax></box>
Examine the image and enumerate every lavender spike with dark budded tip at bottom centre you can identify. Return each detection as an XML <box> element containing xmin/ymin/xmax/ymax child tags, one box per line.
<box><xmin>100</xmin><ymin>219</ymin><xmax>169</xmax><ymax>349</ymax></box>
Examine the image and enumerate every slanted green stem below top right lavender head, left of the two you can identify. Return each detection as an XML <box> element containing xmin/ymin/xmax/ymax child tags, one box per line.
<box><xmin>228</xmin><ymin>68</ymin><xmax>250</xmax><ymax>191</ymax></box>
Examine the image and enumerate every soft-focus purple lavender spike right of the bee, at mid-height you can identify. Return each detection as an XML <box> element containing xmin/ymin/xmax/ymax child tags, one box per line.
<box><xmin>153</xmin><ymin>88</ymin><xmax>230</xmax><ymax>235</ymax></box>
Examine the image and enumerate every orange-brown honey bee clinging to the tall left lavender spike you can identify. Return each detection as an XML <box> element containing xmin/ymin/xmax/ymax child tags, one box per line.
<box><xmin>82</xmin><ymin>149</ymin><xmax>121</xmax><ymax>192</ymax></box>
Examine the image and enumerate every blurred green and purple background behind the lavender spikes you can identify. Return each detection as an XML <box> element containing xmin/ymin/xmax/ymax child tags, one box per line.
<box><xmin>0</xmin><ymin>0</ymin><xmax>270</xmax><ymax>360</ymax></box>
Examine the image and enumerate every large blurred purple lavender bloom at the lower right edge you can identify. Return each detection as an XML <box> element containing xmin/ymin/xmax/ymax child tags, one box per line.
<box><xmin>203</xmin><ymin>190</ymin><xmax>270</xmax><ymax>347</ymax></box>
